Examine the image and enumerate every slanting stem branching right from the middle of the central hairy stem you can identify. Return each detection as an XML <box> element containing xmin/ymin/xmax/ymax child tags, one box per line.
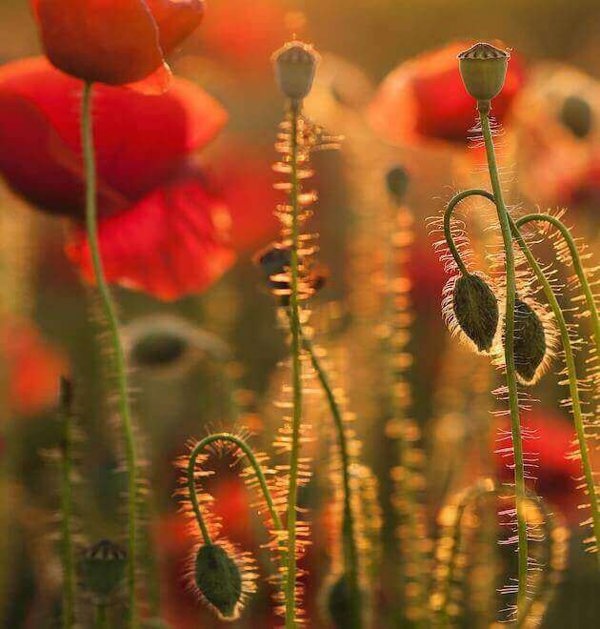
<box><xmin>300</xmin><ymin>330</ymin><xmax>362</xmax><ymax>629</ymax></box>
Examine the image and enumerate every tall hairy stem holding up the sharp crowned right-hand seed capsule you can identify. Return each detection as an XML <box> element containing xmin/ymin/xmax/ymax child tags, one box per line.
<box><xmin>479</xmin><ymin>103</ymin><xmax>528</xmax><ymax>625</ymax></box>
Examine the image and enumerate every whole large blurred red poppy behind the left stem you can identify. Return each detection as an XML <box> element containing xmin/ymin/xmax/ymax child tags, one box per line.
<box><xmin>0</xmin><ymin>58</ymin><xmax>234</xmax><ymax>299</ymax></box>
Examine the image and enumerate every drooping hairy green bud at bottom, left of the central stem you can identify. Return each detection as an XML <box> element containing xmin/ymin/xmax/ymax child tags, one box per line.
<box><xmin>194</xmin><ymin>544</ymin><xmax>242</xmax><ymax>620</ymax></box>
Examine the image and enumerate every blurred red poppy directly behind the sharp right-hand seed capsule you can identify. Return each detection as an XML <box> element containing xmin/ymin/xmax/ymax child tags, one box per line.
<box><xmin>369</xmin><ymin>42</ymin><xmax>524</xmax><ymax>144</ymax></box>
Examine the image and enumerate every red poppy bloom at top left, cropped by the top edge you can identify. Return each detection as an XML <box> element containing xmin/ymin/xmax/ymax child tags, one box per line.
<box><xmin>32</xmin><ymin>0</ymin><xmax>204</xmax><ymax>91</ymax></box>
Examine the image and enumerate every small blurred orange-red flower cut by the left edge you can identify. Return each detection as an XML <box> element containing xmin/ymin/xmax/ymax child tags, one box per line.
<box><xmin>0</xmin><ymin>319</ymin><xmax>68</xmax><ymax>416</ymax></box>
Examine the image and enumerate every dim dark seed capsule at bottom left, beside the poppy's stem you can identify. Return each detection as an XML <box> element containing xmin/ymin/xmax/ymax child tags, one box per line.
<box><xmin>79</xmin><ymin>539</ymin><xmax>127</xmax><ymax>601</ymax></box>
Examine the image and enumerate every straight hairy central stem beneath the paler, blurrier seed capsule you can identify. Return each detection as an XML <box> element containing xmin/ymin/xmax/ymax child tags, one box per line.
<box><xmin>284</xmin><ymin>102</ymin><xmax>302</xmax><ymax>629</ymax></box>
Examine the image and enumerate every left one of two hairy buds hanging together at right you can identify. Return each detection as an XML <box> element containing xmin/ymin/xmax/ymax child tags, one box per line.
<box><xmin>452</xmin><ymin>273</ymin><xmax>500</xmax><ymax>352</ymax></box>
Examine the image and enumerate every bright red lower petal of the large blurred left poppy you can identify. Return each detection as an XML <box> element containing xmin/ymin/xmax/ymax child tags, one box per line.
<box><xmin>67</xmin><ymin>172</ymin><xmax>235</xmax><ymax>301</ymax></box>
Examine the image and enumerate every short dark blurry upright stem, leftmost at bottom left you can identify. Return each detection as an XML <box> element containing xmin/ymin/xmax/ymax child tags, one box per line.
<box><xmin>60</xmin><ymin>378</ymin><xmax>75</xmax><ymax>629</ymax></box>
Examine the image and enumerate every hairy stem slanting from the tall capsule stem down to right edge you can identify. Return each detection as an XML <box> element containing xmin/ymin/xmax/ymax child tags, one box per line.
<box><xmin>510</xmin><ymin>219</ymin><xmax>600</xmax><ymax>563</ymax></box>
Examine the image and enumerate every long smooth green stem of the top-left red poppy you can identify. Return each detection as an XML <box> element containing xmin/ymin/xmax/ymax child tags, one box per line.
<box><xmin>81</xmin><ymin>83</ymin><xmax>138</xmax><ymax>629</ymax></box>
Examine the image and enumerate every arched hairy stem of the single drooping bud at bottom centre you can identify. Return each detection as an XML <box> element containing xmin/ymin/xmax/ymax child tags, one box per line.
<box><xmin>187</xmin><ymin>432</ymin><xmax>283</xmax><ymax>544</ymax></box>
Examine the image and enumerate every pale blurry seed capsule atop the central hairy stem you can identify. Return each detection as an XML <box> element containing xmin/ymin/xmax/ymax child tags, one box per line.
<box><xmin>272</xmin><ymin>41</ymin><xmax>319</xmax><ymax>103</ymax></box>
